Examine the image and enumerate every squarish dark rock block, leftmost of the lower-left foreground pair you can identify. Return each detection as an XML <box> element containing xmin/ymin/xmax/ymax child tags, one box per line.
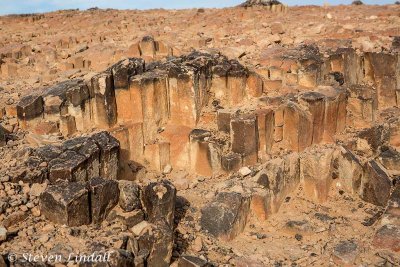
<box><xmin>40</xmin><ymin>183</ymin><xmax>90</xmax><ymax>226</ymax></box>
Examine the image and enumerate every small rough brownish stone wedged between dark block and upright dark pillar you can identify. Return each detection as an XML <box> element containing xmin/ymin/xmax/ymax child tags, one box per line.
<box><xmin>118</xmin><ymin>180</ymin><xmax>142</xmax><ymax>212</ymax></box>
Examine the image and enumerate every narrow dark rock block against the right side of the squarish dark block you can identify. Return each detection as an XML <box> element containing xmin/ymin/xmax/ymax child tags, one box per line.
<box><xmin>88</xmin><ymin>177</ymin><xmax>119</xmax><ymax>223</ymax></box>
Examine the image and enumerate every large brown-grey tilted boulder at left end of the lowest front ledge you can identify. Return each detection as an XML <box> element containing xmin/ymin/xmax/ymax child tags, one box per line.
<box><xmin>200</xmin><ymin>192</ymin><xmax>250</xmax><ymax>240</ymax></box>
